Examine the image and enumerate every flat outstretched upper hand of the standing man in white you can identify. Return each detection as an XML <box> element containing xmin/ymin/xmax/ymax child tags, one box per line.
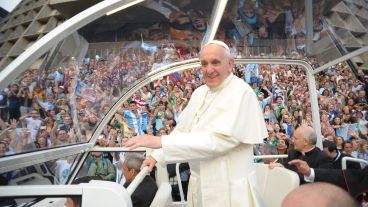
<box><xmin>123</xmin><ymin>134</ymin><xmax>162</xmax><ymax>149</ymax></box>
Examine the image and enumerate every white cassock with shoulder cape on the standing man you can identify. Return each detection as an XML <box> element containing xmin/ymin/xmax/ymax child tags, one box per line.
<box><xmin>152</xmin><ymin>74</ymin><xmax>268</xmax><ymax>207</ymax></box>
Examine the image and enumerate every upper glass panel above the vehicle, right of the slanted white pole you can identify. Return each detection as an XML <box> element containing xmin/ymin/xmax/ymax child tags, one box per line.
<box><xmin>217</xmin><ymin>0</ymin><xmax>306</xmax><ymax>58</ymax></box>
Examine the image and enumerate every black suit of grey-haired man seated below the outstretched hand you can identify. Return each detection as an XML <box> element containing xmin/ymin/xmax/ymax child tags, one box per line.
<box><xmin>124</xmin><ymin>175</ymin><xmax>157</xmax><ymax>207</ymax></box>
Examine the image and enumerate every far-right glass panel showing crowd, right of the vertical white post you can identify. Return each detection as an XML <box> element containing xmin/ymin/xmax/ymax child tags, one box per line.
<box><xmin>316</xmin><ymin>52</ymin><xmax>368</xmax><ymax>160</ymax></box>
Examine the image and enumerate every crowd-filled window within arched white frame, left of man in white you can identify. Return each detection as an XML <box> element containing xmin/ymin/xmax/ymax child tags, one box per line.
<box><xmin>98</xmin><ymin>65</ymin><xmax>203</xmax><ymax>142</ymax></box>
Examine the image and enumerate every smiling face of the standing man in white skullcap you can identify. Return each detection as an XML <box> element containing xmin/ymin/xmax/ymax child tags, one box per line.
<box><xmin>200</xmin><ymin>44</ymin><xmax>234</xmax><ymax>89</ymax></box>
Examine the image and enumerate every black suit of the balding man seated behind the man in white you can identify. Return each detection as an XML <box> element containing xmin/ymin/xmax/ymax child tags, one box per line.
<box><xmin>284</xmin><ymin>147</ymin><xmax>333</xmax><ymax>184</ymax></box>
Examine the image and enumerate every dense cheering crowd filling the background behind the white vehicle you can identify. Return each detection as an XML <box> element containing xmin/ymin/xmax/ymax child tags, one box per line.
<box><xmin>0</xmin><ymin>37</ymin><xmax>367</xmax><ymax>176</ymax></box>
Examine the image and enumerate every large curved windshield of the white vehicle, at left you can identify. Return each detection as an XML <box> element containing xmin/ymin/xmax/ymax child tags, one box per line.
<box><xmin>1</xmin><ymin>1</ymin><xmax>213</xmax><ymax>155</ymax></box>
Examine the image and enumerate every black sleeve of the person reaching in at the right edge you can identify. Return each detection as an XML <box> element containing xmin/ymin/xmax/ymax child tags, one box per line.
<box><xmin>314</xmin><ymin>167</ymin><xmax>368</xmax><ymax>201</ymax></box>
